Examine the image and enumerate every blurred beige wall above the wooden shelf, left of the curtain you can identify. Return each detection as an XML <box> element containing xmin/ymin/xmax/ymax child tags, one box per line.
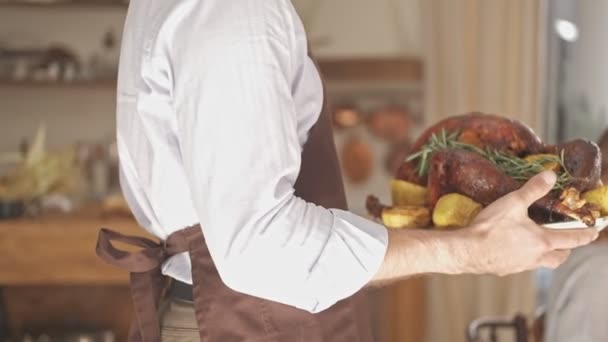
<box><xmin>293</xmin><ymin>0</ymin><xmax>421</xmax><ymax>57</ymax></box>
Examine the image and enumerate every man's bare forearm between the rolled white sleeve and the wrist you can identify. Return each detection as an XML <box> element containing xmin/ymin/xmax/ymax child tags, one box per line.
<box><xmin>370</xmin><ymin>229</ymin><xmax>478</xmax><ymax>286</ymax></box>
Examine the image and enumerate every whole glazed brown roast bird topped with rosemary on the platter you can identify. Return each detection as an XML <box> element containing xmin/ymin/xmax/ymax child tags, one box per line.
<box><xmin>366</xmin><ymin>113</ymin><xmax>604</xmax><ymax>230</ymax></box>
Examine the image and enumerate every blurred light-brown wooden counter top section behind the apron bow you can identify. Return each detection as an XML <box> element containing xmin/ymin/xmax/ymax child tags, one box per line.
<box><xmin>0</xmin><ymin>208</ymin><xmax>149</xmax><ymax>286</ymax></box>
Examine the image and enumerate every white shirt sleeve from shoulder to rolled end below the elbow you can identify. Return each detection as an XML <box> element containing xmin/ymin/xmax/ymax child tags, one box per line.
<box><xmin>171</xmin><ymin>0</ymin><xmax>388</xmax><ymax>313</ymax></box>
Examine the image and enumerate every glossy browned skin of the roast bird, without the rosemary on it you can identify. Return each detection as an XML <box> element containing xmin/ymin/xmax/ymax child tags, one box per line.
<box><xmin>376</xmin><ymin>113</ymin><xmax>601</xmax><ymax>225</ymax></box>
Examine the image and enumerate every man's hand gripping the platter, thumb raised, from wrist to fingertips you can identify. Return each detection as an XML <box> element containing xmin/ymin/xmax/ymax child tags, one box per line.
<box><xmin>466</xmin><ymin>171</ymin><xmax>598</xmax><ymax>275</ymax></box>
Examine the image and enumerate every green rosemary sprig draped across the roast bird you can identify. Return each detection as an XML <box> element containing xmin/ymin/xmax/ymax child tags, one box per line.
<box><xmin>406</xmin><ymin>130</ymin><xmax>572</xmax><ymax>190</ymax></box>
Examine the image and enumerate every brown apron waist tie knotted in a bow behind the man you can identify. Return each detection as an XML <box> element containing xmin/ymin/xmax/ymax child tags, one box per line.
<box><xmin>96</xmin><ymin>225</ymin><xmax>204</xmax><ymax>342</ymax></box>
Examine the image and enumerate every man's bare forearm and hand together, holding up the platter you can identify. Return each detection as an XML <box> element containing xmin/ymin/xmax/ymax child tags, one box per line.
<box><xmin>372</xmin><ymin>171</ymin><xmax>598</xmax><ymax>284</ymax></box>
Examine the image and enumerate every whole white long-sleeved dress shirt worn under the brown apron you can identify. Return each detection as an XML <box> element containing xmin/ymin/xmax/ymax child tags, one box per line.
<box><xmin>117</xmin><ymin>0</ymin><xmax>388</xmax><ymax>312</ymax></box>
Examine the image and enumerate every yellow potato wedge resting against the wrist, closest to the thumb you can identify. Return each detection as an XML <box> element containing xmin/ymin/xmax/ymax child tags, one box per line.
<box><xmin>433</xmin><ymin>193</ymin><xmax>482</xmax><ymax>228</ymax></box>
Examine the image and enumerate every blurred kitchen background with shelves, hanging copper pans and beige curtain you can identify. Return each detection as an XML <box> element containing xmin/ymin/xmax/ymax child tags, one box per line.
<box><xmin>0</xmin><ymin>0</ymin><xmax>608</xmax><ymax>342</ymax></box>
